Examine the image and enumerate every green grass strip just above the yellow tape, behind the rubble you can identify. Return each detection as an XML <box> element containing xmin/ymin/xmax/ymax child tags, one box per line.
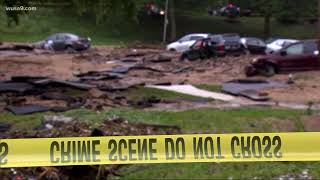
<box><xmin>0</xmin><ymin>108</ymin><xmax>304</xmax><ymax>134</ymax></box>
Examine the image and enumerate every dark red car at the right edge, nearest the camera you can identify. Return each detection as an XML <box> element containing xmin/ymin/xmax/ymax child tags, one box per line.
<box><xmin>246</xmin><ymin>40</ymin><xmax>320</xmax><ymax>76</ymax></box>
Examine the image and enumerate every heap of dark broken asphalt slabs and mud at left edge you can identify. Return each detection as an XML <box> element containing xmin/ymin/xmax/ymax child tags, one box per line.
<box><xmin>0</xmin><ymin>77</ymin><xmax>128</xmax><ymax>115</ymax></box>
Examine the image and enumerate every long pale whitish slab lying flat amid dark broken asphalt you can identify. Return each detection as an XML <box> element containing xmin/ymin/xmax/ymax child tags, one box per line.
<box><xmin>146</xmin><ymin>85</ymin><xmax>235</xmax><ymax>101</ymax></box>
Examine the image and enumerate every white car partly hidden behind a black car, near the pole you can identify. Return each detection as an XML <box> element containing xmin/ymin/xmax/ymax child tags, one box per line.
<box><xmin>167</xmin><ymin>33</ymin><xmax>210</xmax><ymax>52</ymax></box>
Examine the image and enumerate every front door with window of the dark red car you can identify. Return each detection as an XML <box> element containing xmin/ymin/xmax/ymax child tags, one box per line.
<box><xmin>278</xmin><ymin>43</ymin><xmax>310</xmax><ymax>71</ymax></box>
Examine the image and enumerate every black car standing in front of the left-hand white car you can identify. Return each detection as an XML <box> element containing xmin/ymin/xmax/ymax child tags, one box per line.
<box><xmin>180</xmin><ymin>38</ymin><xmax>216</xmax><ymax>61</ymax></box>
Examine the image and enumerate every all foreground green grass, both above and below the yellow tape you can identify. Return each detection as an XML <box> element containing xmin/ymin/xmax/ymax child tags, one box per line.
<box><xmin>0</xmin><ymin>108</ymin><xmax>320</xmax><ymax>179</ymax></box>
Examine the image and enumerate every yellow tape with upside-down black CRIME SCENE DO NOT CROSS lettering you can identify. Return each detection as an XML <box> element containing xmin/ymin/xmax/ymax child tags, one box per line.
<box><xmin>0</xmin><ymin>132</ymin><xmax>320</xmax><ymax>168</ymax></box>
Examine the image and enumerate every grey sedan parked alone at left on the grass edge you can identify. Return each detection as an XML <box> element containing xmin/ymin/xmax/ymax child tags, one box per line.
<box><xmin>36</xmin><ymin>33</ymin><xmax>91</xmax><ymax>51</ymax></box>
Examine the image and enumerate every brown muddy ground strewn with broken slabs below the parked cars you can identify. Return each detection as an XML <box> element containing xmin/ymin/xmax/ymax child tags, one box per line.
<box><xmin>0</xmin><ymin>46</ymin><xmax>320</xmax><ymax>104</ymax></box>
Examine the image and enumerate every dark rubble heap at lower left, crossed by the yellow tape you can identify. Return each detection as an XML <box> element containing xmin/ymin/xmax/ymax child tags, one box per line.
<box><xmin>0</xmin><ymin>116</ymin><xmax>181</xmax><ymax>180</ymax></box>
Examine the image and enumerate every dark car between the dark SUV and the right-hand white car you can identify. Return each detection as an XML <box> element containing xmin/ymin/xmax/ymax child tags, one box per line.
<box><xmin>240</xmin><ymin>37</ymin><xmax>267</xmax><ymax>54</ymax></box>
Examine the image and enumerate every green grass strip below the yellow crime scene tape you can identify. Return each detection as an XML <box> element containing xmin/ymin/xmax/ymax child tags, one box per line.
<box><xmin>117</xmin><ymin>162</ymin><xmax>320</xmax><ymax>179</ymax></box>
